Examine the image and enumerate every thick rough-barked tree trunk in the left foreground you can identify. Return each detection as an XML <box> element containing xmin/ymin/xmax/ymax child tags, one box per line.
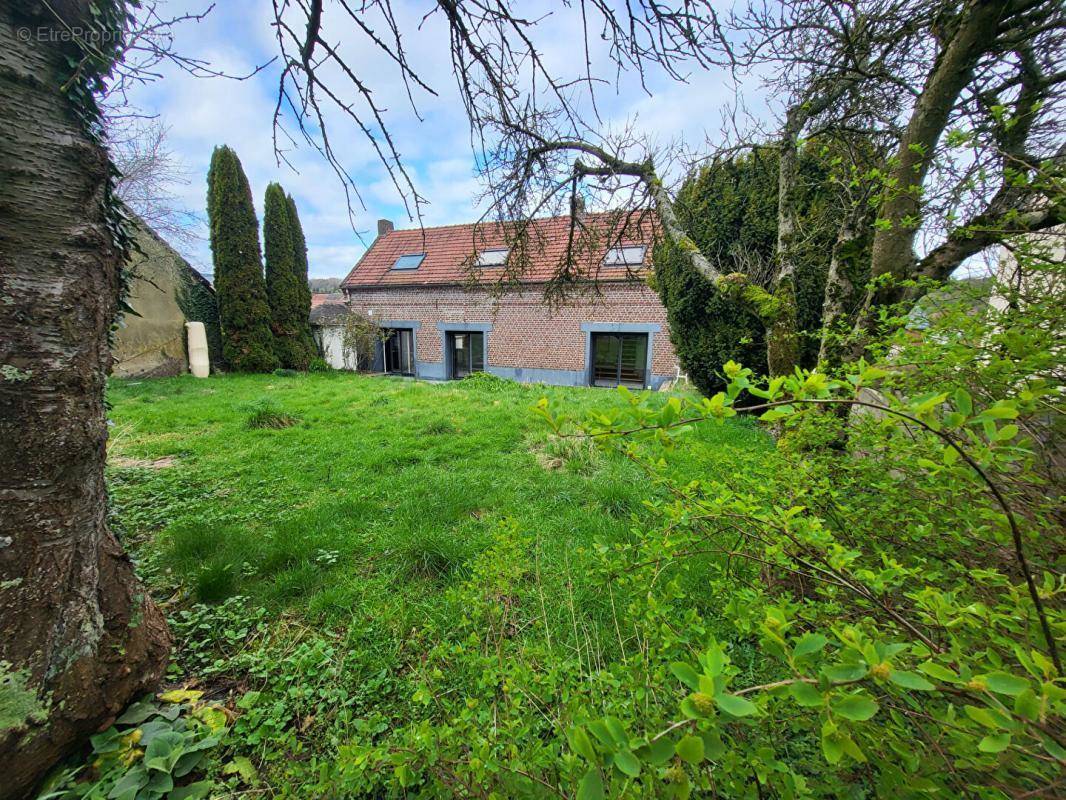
<box><xmin>0</xmin><ymin>0</ymin><xmax>169</xmax><ymax>798</ymax></box>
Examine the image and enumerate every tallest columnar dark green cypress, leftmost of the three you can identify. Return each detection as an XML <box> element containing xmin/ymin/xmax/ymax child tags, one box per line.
<box><xmin>207</xmin><ymin>145</ymin><xmax>278</xmax><ymax>372</ymax></box>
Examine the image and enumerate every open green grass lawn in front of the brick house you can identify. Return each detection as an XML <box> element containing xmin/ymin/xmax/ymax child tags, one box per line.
<box><xmin>109</xmin><ymin>374</ymin><xmax>765</xmax><ymax>631</ymax></box>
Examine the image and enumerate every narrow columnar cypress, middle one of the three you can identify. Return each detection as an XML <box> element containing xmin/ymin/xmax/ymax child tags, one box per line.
<box><xmin>263</xmin><ymin>183</ymin><xmax>313</xmax><ymax>369</ymax></box>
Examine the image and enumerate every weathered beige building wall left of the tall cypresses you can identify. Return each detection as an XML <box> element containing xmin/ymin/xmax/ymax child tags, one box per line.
<box><xmin>111</xmin><ymin>220</ymin><xmax>222</xmax><ymax>378</ymax></box>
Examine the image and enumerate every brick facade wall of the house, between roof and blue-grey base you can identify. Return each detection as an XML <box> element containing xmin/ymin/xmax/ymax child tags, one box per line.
<box><xmin>348</xmin><ymin>283</ymin><xmax>677</xmax><ymax>384</ymax></box>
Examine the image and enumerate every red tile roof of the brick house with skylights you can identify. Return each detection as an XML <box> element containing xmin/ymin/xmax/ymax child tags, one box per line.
<box><xmin>341</xmin><ymin>213</ymin><xmax>655</xmax><ymax>289</ymax></box>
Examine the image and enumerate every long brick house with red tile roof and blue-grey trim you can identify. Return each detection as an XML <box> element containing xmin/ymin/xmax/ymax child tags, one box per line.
<box><xmin>341</xmin><ymin>214</ymin><xmax>677</xmax><ymax>388</ymax></box>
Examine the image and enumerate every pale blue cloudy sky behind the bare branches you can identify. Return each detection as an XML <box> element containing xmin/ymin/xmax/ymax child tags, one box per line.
<box><xmin>122</xmin><ymin>0</ymin><xmax>765</xmax><ymax>277</ymax></box>
